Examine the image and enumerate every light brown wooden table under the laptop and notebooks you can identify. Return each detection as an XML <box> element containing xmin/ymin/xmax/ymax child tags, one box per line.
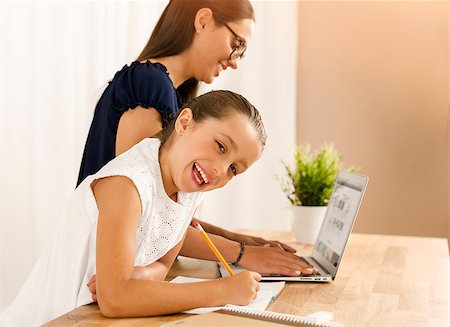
<box><xmin>46</xmin><ymin>232</ymin><xmax>449</xmax><ymax>327</ymax></box>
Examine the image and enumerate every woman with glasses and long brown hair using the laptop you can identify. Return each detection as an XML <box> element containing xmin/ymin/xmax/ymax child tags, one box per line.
<box><xmin>77</xmin><ymin>0</ymin><xmax>311</xmax><ymax>282</ymax></box>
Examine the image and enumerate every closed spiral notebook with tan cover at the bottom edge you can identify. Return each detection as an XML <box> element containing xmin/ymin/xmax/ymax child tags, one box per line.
<box><xmin>162</xmin><ymin>304</ymin><xmax>343</xmax><ymax>327</ymax></box>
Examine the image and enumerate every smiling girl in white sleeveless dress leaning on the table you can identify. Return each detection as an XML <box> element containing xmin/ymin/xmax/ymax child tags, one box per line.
<box><xmin>0</xmin><ymin>91</ymin><xmax>266</xmax><ymax>326</ymax></box>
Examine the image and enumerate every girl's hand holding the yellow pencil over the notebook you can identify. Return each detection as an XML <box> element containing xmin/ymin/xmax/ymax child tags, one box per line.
<box><xmin>220</xmin><ymin>271</ymin><xmax>261</xmax><ymax>305</ymax></box>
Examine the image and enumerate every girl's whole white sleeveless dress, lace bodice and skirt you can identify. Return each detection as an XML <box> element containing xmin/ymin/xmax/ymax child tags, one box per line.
<box><xmin>0</xmin><ymin>139</ymin><xmax>202</xmax><ymax>326</ymax></box>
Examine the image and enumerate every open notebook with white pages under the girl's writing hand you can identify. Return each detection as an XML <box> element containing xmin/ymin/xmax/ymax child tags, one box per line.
<box><xmin>170</xmin><ymin>276</ymin><xmax>285</xmax><ymax>314</ymax></box>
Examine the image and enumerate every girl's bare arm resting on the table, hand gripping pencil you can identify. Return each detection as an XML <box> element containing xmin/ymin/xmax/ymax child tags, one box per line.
<box><xmin>92</xmin><ymin>176</ymin><xmax>261</xmax><ymax>317</ymax></box>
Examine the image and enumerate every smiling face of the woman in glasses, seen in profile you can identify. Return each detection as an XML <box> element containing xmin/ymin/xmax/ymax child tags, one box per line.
<box><xmin>192</xmin><ymin>19</ymin><xmax>254</xmax><ymax>83</ymax></box>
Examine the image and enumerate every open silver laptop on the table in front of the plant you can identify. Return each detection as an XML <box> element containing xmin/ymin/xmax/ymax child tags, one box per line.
<box><xmin>219</xmin><ymin>171</ymin><xmax>369</xmax><ymax>282</ymax></box>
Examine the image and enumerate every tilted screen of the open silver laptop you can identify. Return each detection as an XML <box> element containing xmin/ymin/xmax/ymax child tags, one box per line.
<box><xmin>313</xmin><ymin>171</ymin><xmax>368</xmax><ymax>276</ymax></box>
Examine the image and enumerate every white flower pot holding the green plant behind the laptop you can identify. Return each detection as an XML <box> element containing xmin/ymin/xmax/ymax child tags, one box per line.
<box><xmin>292</xmin><ymin>206</ymin><xmax>327</xmax><ymax>244</ymax></box>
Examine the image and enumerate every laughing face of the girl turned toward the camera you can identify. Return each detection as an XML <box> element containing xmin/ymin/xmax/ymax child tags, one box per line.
<box><xmin>161</xmin><ymin>109</ymin><xmax>261</xmax><ymax>195</ymax></box>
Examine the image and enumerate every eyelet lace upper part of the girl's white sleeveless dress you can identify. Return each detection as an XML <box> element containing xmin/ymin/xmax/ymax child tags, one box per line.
<box><xmin>84</xmin><ymin>139</ymin><xmax>202</xmax><ymax>266</ymax></box>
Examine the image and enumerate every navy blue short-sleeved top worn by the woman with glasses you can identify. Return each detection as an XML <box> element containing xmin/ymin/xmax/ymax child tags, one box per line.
<box><xmin>77</xmin><ymin>61</ymin><xmax>182</xmax><ymax>186</ymax></box>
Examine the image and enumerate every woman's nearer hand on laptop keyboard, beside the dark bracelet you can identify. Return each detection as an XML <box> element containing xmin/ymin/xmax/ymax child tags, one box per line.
<box><xmin>239</xmin><ymin>246</ymin><xmax>316</xmax><ymax>276</ymax></box>
